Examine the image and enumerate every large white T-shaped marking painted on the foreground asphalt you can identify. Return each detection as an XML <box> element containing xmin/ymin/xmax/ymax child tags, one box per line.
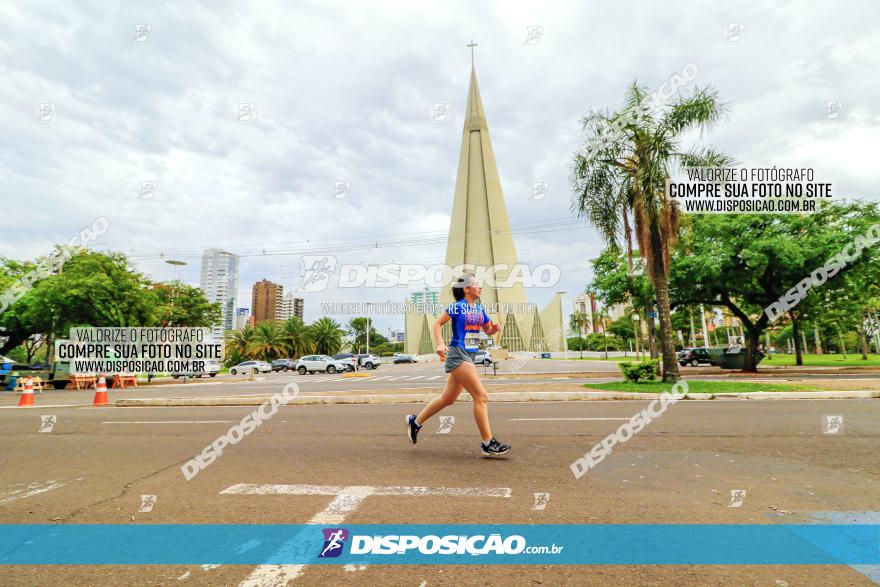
<box><xmin>220</xmin><ymin>483</ymin><xmax>511</xmax><ymax>587</ymax></box>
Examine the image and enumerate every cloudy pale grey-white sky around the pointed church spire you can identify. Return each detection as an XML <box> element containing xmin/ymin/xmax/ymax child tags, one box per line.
<box><xmin>0</xmin><ymin>0</ymin><xmax>880</xmax><ymax>333</ymax></box>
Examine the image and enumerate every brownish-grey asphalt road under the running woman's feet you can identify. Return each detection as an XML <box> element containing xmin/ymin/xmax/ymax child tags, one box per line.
<box><xmin>0</xmin><ymin>400</ymin><xmax>880</xmax><ymax>587</ymax></box>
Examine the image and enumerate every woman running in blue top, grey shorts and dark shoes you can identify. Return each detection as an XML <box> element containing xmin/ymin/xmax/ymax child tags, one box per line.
<box><xmin>406</xmin><ymin>273</ymin><xmax>510</xmax><ymax>457</ymax></box>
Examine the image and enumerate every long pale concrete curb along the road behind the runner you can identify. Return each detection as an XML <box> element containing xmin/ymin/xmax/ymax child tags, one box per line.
<box><xmin>116</xmin><ymin>391</ymin><xmax>880</xmax><ymax>408</ymax></box>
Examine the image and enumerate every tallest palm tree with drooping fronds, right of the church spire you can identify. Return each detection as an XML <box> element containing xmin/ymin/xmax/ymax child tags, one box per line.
<box><xmin>571</xmin><ymin>82</ymin><xmax>733</xmax><ymax>382</ymax></box>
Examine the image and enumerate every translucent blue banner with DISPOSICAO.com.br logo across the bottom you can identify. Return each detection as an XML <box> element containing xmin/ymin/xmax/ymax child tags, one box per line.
<box><xmin>0</xmin><ymin>524</ymin><xmax>880</xmax><ymax>565</ymax></box>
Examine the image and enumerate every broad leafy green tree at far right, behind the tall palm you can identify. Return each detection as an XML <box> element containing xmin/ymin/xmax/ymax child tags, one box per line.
<box><xmin>670</xmin><ymin>202</ymin><xmax>878</xmax><ymax>371</ymax></box>
